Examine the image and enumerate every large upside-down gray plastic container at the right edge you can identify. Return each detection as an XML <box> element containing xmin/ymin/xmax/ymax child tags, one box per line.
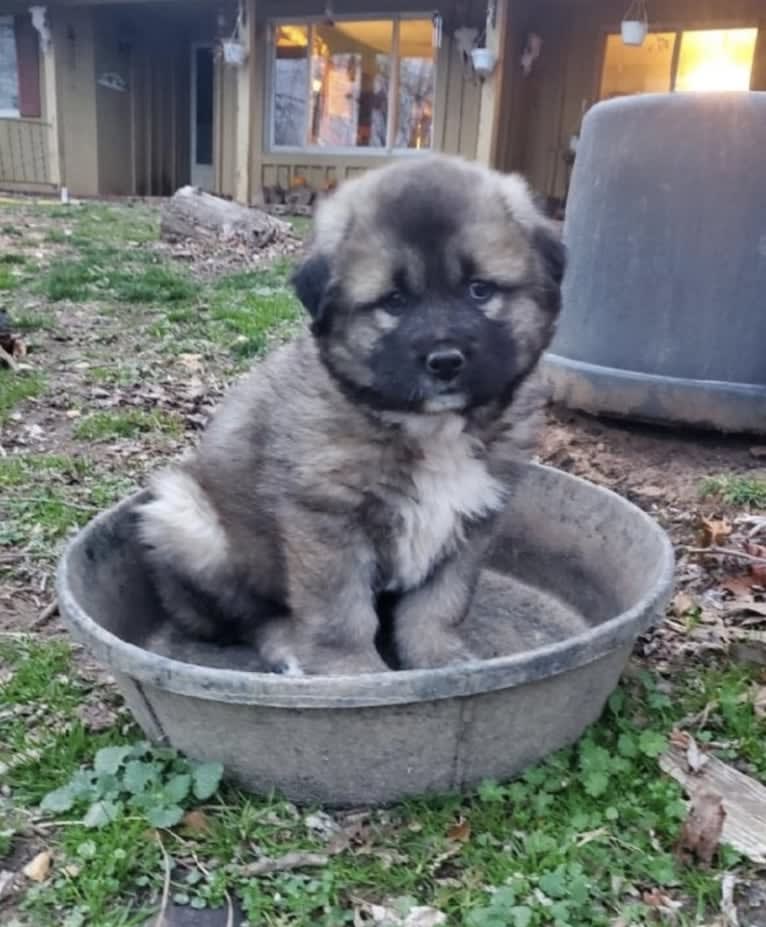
<box><xmin>544</xmin><ymin>93</ymin><xmax>766</xmax><ymax>433</ymax></box>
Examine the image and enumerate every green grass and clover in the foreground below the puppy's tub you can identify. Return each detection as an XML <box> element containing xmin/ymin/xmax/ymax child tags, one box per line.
<box><xmin>0</xmin><ymin>639</ymin><xmax>766</xmax><ymax>927</ymax></box>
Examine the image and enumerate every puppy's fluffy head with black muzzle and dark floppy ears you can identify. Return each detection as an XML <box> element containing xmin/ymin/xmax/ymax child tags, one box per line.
<box><xmin>294</xmin><ymin>157</ymin><xmax>564</xmax><ymax>413</ymax></box>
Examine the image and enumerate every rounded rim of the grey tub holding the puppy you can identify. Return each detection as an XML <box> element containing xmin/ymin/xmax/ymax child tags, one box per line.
<box><xmin>56</xmin><ymin>463</ymin><xmax>675</xmax><ymax>709</ymax></box>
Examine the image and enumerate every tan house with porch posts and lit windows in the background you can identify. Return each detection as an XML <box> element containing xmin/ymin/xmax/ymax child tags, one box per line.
<box><xmin>0</xmin><ymin>0</ymin><xmax>766</xmax><ymax>202</ymax></box>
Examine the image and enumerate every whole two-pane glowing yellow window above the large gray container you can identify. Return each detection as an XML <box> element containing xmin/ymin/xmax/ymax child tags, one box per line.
<box><xmin>600</xmin><ymin>29</ymin><xmax>758</xmax><ymax>100</ymax></box>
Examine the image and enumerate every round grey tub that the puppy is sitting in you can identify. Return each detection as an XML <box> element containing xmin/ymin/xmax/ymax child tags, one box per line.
<box><xmin>57</xmin><ymin>465</ymin><xmax>673</xmax><ymax>806</ymax></box>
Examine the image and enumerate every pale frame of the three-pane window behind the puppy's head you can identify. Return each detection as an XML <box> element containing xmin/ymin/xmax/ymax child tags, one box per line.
<box><xmin>264</xmin><ymin>10</ymin><xmax>441</xmax><ymax>158</ymax></box>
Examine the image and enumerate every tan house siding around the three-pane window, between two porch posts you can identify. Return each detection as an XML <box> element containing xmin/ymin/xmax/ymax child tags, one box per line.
<box><xmin>250</xmin><ymin>0</ymin><xmax>484</xmax><ymax>199</ymax></box>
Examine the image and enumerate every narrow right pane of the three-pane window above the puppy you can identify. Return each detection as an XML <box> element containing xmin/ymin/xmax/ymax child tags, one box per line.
<box><xmin>394</xmin><ymin>19</ymin><xmax>436</xmax><ymax>148</ymax></box>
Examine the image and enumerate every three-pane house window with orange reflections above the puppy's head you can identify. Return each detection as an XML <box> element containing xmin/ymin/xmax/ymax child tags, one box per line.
<box><xmin>271</xmin><ymin>18</ymin><xmax>435</xmax><ymax>152</ymax></box>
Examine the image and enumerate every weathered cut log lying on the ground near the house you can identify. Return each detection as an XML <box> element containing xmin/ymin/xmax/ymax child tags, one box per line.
<box><xmin>160</xmin><ymin>186</ymin><xmax>293</xmax><ymax>249</ymax></box>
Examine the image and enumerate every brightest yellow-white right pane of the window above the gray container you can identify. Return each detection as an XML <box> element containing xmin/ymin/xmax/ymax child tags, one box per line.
<box><xmin>676</xmin><ymin>29</ymin><xmax>758</xmax><ymax>91</ymax></box>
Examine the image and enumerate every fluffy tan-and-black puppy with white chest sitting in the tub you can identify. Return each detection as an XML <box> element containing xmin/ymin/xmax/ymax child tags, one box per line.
<box><xmin>139</xmin><ymin>156</ymin><xmax>565</xmax><ymax>674</ymax></box>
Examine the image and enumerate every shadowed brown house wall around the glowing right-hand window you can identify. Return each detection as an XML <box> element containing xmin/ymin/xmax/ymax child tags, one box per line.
<box><xmin>510</xmin><ymin>0</ymin><xmax>766</xmax><ymax>196</ymax></box>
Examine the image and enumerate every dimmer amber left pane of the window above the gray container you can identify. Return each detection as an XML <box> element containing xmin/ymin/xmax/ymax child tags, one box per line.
<box><xmin>601</xmin><ymin>32</ymin><xmax>676</xmax><ymax>100</ymax></box>
